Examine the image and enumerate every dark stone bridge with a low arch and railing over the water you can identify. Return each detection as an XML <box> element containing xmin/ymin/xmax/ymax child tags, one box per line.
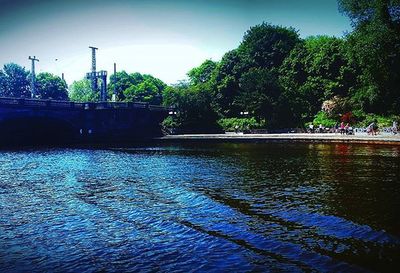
<box><xmin>0</xmin><ymin>98</ymin><xmax>171</xmax><ymax>146</ymax></box>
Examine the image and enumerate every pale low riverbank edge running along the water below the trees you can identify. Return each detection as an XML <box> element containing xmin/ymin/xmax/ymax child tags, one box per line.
<box><xmin>159</xmin><ymin>133</ymin><xmax>400</xmax><ymax>145</ymax></box>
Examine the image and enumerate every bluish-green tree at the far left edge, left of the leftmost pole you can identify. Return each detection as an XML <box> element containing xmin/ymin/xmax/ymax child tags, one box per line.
<box><xmin>0</xmin><ymin>63</ymin><xmax>31</xmax><ymax>98</ymax></box>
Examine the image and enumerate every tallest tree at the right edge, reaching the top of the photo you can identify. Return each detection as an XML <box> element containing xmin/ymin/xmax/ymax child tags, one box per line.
<box><xmin>339</xmin><ymin>0</ymin><xmax>400</xmax><ymax>114</ymax></box>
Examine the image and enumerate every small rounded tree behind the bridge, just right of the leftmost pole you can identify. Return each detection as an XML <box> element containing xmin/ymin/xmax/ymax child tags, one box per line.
<box><xmin>36</xmin><ymin>72</ymin><xmax>68</xmax><ymax>100</ymax></box>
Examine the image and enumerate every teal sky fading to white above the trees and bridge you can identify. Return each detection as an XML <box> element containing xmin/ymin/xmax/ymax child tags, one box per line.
<box><xmin>0</xmin><ymin>0</ymin><xmax>351</xmax><ymax>84</ymax></box>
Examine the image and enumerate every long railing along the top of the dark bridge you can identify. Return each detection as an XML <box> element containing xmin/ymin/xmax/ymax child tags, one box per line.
<box><xmin>0</xmin><ymin>97</ymin><xmax>172</xmax><ymax>111</ymax></box>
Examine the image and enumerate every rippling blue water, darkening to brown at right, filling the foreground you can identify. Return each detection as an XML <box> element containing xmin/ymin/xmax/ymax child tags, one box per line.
<box><xmin>0</xmin><ymin>143</ymin><xmax>400</xmax><ymax>272</ymax></box>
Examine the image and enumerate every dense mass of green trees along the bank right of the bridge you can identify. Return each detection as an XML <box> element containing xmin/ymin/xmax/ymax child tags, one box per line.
<box><xmin>164</xmin><ymin>0</ymin><xmax>400</xmax><ymax>132</ymax></box>
